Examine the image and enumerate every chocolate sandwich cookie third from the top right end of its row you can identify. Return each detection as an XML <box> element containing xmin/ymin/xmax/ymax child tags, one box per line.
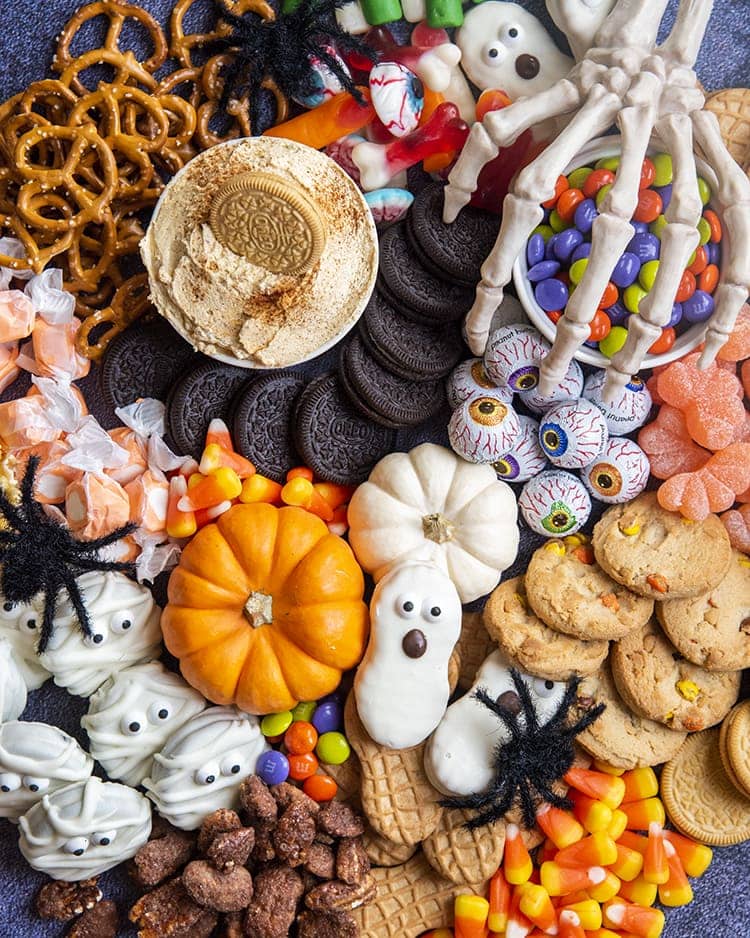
<box><xmin>359</xmin><ymin>291</ymin><xmax>463</xmax><ymax>381</ymax></box>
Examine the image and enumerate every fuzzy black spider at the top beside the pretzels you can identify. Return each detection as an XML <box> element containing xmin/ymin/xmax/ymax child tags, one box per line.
<box><xmin>215</xmin><ymin>0</ymin><xmax>377</xmax><ymax>127</ymax></box>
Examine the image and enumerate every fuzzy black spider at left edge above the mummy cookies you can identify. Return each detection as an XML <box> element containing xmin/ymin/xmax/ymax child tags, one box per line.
<box><xmin>0</xmin><ymin>456</ymin><xmax>135</xmax><ymax>654</ymax></box>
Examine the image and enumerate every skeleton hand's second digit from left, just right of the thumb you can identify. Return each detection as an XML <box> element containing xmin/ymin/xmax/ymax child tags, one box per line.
<box><xmin>465</xmin><ymin>85</ymin><xmax>621</xmax><ymax>355</ymax></box>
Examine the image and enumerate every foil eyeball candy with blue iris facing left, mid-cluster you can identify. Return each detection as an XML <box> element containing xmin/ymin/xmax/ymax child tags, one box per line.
<box><xmin>539</xmin><ymin>398</ymin><xmax>609</xmax><ymax>469</ymax></box>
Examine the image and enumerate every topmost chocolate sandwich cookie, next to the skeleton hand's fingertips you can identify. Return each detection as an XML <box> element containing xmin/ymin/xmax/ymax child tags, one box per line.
<box><xmin>407</xmin><ymin>183</ymin><xmax>500</xmax><ymax>286</ymax></box>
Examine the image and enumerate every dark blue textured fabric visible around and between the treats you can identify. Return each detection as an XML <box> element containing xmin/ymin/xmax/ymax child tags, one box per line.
<box><xmin>0</xmin><ymin>0</ymin><xmax>750</xmax><ymax>938</ymax></box>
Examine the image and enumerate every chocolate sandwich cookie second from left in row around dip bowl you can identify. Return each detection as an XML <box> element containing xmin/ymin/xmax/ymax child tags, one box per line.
<box><xmin>167</xmin><ymin>361</ymin><xmax>251</xmax><ymax>459</ymax></box>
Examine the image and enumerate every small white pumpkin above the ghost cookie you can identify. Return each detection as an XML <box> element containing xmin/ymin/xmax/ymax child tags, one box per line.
<box><xmin>348</xmin><ymin>443</ymin><xmax>518</xmax><ymax>603</ymax></box>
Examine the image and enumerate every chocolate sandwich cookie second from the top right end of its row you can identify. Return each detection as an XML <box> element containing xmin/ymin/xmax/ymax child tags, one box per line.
<box><xmin>379</xmin><ymin>222</ymin><xmax>474</xmax><ymax>325</ymax></box>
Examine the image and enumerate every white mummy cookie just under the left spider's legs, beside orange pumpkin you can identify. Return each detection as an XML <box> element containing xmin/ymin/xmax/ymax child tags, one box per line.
<box><xmin>39</xmin><ymin>571</ymin><xmax>161</xmax><ymax>697</ymax></box>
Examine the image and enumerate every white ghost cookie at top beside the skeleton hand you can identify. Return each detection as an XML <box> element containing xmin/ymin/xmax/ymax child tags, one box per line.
<box><xmin>456</xmin><ymin>0</ymin><xmax>573</xmax><ymax>101</ymax></box>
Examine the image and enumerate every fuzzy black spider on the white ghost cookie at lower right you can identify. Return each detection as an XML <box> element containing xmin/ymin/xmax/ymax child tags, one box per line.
<box><xmin>440</xmin><ymin>668</ymin><xmax>605</xmax><ymax>830</ymax></box>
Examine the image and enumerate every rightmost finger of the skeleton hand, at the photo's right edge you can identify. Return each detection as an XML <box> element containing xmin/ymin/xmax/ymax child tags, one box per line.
<box><xmin>692</xmin><ymin>111</ymin><xmax>750</xmax><ymax>368</ymax></box>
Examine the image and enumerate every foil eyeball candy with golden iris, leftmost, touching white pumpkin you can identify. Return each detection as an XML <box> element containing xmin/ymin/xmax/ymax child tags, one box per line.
<box><xmin>448</xmin><ymin>394</ymin><xmax>521</xmax><ymax>462</ymax></box>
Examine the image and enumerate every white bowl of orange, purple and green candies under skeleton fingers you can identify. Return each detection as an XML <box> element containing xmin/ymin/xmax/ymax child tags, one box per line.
<box><xmin>513</xmin><ymin>135</ymin><xmax>722</xmax><ymax>368</ymax></box>
